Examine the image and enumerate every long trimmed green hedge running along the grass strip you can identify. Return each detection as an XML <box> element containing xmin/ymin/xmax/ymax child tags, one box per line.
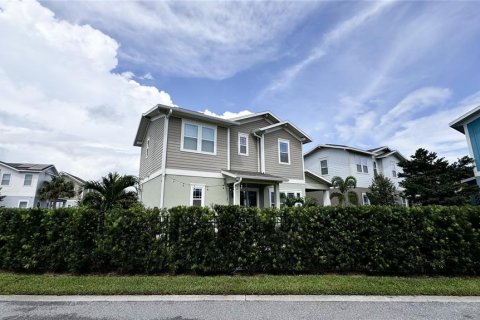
<box><xmin>0</xmin><ymin>206</ymin><xmax>480</xmax><ymax>275</ymax></box>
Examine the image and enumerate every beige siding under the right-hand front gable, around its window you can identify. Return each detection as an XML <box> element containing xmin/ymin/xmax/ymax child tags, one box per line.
<box><xmin>265</xmin><ymin>129</ymin><xmax>303</xmax><ymax>180</ymax></box>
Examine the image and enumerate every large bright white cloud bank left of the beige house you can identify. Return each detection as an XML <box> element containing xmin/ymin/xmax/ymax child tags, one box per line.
<box><xmin>0</xmin><ymin>1</ymin><xmax>172</xmax><ymax>179</ymax></box>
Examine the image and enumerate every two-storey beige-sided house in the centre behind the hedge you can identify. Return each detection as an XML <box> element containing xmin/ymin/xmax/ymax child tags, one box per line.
<box><xmin>134</xmin><ymin>105</ymin><xmax>331</xmax><ymax>208</ymax></box>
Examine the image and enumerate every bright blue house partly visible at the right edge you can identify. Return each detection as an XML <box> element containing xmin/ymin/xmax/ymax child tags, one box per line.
<box><xmin>449</xmin><ymin>106</ymin><xmax>480</xmax><ymax>186</ymax></box>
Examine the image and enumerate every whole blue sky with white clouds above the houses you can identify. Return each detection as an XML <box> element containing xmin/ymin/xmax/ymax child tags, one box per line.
<box><xmin>0</xmin><ymin>0</ymin><xmax>480</xmax><ymax>179</ymax></box>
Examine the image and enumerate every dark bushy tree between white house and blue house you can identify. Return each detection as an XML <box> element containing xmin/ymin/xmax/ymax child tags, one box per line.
<box><xmin>398</xmin><ymin>148</ymin><xmax>479</xmax><ymax>205</ymax></box>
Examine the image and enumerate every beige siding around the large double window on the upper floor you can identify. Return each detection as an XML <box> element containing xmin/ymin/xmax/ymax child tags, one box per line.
<box><xmin>167</xmin><ymin>117</ymin><xmax>227</xmax><ymax>172</ymax></box>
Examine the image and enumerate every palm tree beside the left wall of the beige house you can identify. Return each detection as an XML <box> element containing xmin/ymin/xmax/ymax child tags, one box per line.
<box><xmin>82</xmin><ymin>172</ymin><xmax>138</xmax><ymax>211</ymax></box>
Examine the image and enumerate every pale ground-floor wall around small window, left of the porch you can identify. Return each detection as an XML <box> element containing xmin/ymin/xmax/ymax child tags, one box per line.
<box><xmin>164</xmin><ymin>174</ymin><xmax>228</xmax><ymax>208</ymax></box>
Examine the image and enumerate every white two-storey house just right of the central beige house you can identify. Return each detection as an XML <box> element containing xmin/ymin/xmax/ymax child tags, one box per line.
<box><xmin>304</xmin><ymin>144</ymin><xmax>406</xmax><ymax>205</ymax></box>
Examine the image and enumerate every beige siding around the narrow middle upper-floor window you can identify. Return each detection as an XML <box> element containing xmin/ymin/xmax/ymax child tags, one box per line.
<box><xmin>230</xmin><ymin>119</ymin><xmax>270</xmax><ymax>172</ymax></box>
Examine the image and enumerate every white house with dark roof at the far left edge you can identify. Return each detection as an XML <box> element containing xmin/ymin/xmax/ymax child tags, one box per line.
<box><xmin>0</xmin><ymin>161</ymin><xmax>58</xmax><ymax>208</ymax></box>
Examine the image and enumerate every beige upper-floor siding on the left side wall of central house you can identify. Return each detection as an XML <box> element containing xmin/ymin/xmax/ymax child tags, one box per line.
<box><xmin>140</xmin><ymin>118</ymin><xmax>165</xmax><ymax>179</ymax></box>
